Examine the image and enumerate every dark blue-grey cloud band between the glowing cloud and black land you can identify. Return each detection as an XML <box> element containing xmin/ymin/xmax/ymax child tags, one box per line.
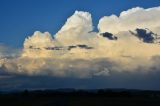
<box><xmin>0</xmin><ymin>72</ymin><xmax>160</xmax><ymax>90</ymax></box>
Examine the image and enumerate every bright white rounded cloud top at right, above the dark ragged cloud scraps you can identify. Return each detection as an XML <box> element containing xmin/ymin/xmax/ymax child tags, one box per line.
<box><xmin>98</xmin><ymin>7</ymin><xmax>160</xmax><ymax>34</ymax></box>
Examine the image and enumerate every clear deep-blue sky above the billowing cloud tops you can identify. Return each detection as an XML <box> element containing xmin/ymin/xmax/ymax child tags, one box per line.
<box><xmin>0</xmin><ymin>0</ymin><xmax>160</xmax><ymax>47</ymax></box>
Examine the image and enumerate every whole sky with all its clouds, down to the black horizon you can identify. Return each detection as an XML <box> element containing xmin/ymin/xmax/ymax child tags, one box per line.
<box><xmin>0</xmin><ymin>0</ymin><xmax>160</xmax><ymax>90</ymax></box>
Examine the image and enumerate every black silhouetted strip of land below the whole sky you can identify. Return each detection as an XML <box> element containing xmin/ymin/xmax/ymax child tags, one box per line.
<box><xmin>0</xmin><ymin>89</ymin><xmax>160</xmax><ymax>106</ymax></box>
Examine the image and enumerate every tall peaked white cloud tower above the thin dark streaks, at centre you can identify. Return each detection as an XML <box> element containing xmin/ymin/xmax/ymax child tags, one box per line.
<box><xmin>55</xmin><ymin>11</ymin><xmax>95</xmax><ymax>45</ymax></box>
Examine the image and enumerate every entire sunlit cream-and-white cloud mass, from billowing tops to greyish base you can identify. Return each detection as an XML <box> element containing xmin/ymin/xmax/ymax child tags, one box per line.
<box><xmin>0</xmin><ymin>7</ymin><xmax>160</xmax><ymax>77</ymax></box>
